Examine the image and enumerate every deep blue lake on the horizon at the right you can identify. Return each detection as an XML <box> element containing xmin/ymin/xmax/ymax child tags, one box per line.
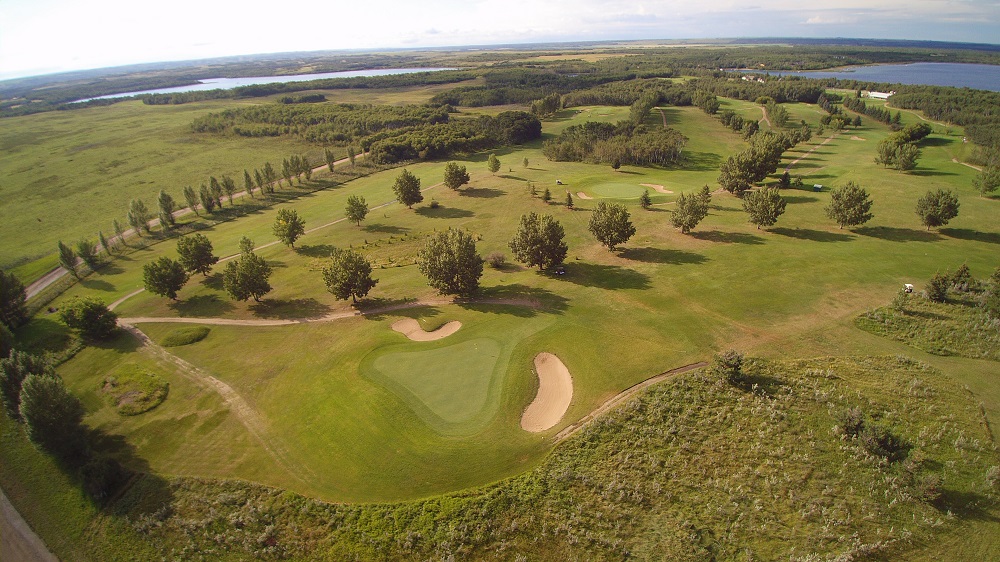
<box><xmin>753</xmin><ymin>62</ymin><xmax>1000</xmax><ymax>92</ymax></box>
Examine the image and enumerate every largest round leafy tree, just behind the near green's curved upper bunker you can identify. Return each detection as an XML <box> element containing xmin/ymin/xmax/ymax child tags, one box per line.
<box><xmin>417</xmin><ymin>228</ymin><xmax>483</xmax><ymax>296</ymax></box>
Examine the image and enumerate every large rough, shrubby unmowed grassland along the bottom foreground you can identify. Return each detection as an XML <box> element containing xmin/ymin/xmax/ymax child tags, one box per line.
<box><xmin>113</xmin><ymin>357</ymin><xmax>998</xmax><ymax>560</ymax></box>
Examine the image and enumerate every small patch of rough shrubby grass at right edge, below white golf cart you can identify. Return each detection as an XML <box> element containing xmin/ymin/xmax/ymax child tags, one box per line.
<box><xmin>855</xmin><ymin>296</ymin><xmax>1000</xmax><ymax>361</ymax></box>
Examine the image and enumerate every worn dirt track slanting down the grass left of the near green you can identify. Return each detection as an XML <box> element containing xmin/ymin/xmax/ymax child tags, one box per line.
<box><xmin>118</xmin><ymin>320</ymin><xmax>316</xmax><ymax>486</ymax></box>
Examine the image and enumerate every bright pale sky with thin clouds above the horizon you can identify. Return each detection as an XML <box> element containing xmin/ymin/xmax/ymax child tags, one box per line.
<box><xmin>0</xmin><ymin>0</ymin><xmax>1000</xmax><ymax>79</ymax></box>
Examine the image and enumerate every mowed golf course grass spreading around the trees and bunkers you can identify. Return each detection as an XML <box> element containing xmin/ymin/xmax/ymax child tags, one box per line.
<box><xmin>23</xmin><ymin>95</ymin><xmax>1000</xmax><ymax>508</ymax></box>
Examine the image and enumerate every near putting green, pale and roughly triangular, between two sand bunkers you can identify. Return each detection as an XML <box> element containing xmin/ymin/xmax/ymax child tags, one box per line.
<box><xmin>372</xmin><ymin>338</ymin><xmax>507</xmax><ymax>429</ymax></box>
